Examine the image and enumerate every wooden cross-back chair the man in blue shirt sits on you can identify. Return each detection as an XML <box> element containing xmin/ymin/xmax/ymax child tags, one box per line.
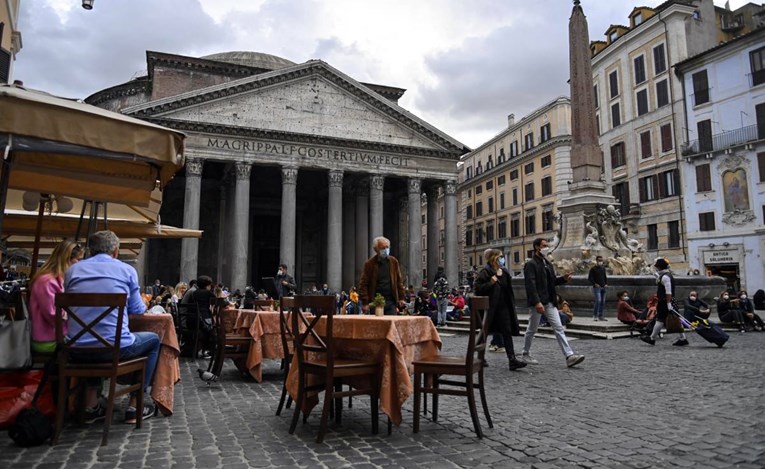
<box><xmin>51</xmin><ymin>293</ymin><xmax>146</xmax><ymax>446</ymax></box>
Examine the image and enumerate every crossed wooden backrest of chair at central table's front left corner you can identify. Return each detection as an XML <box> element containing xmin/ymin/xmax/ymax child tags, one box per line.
<box><xmin>292</xmin><ymin>295</ymin><xmax>335</xmax><ymax>369</ymax></box>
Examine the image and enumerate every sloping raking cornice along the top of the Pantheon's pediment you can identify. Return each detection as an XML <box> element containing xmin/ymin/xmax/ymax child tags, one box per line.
<box><xmin>123</xmin><ymin>59</ymin><xmax>470</xmax><ymax>155</ymax></box>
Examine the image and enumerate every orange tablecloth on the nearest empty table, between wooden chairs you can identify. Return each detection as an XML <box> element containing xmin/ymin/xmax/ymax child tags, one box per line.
<box><xmin>287</xmin><ymin>315</ymin><xmax>441</xmax><ymax>425</ymax></box>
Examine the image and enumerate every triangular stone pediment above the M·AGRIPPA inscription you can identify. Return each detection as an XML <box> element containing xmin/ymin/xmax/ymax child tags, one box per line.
<box><xmin>123</xmin><ymin>60</ymin><xmax>468</xmax><ymax>154</ymax></box>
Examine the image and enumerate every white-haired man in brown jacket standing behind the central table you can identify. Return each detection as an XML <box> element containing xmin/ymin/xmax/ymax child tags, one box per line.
<box><xmin>359</xmin><ymin>236</ymin><xmax>404</xmax><ymax>315</ymax></box>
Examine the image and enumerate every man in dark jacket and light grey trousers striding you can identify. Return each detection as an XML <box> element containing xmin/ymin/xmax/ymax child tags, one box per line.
<box><xmin>521</xmin><ymin>238</ymin><xmax>584</xmax><ymax>368</ymax></box>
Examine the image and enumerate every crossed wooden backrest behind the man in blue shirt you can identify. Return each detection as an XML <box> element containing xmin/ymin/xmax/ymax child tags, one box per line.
<box><xmin>56</xmin><ymin>293</ymin><xmax>127</xmax><ymax>369</ymax></box>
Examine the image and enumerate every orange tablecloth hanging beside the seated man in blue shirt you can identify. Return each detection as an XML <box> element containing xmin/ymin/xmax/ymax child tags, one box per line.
<box><xmin>130</xmin><ymin>314</ymin><xmax>181</xmax><ymax>416</ymax></box>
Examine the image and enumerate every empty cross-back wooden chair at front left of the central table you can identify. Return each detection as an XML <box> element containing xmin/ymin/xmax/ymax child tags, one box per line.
<box><xmin>289</xmin><ymin>295</ymin><xmax>381</xmax><ymax>443</ymax></box>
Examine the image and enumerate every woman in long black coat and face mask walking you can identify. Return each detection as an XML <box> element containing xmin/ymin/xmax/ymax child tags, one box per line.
<box><xmin>473</xmin><ymin>249</ymin><xmax>526</xmax><ymax>370</ymax></box>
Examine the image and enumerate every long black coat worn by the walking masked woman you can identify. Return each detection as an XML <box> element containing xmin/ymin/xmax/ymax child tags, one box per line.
<box><xmin>473</xmin><ymin>264</ymin><xmax>521</xmax><ymax>335</ymax></box>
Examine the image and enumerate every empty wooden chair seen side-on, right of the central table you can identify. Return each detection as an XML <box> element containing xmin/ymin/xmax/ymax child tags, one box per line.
<box><xmin>413</xmin><ymin>296</ymin><xmax>494</xmax><ymax>438</ymax></box>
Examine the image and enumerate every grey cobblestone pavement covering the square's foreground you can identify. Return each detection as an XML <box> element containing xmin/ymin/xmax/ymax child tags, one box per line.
<box><xmin>0</xmin><ymin>333</ymin><xmax>765</xmax><ymax>469</ymax></box>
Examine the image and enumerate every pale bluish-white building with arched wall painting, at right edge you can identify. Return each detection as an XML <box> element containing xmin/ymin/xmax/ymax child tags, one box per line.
<box><xmin>676</xmin><ymin>28</ymin><xmax>765</xmax><ymax>290</ymax></box>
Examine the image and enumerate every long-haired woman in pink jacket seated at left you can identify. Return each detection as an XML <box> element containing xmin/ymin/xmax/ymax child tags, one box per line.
<box><xmin>29</xmin><ymin>240</ymin><xmax>84</xmax><ymax>353</ymax></box>
